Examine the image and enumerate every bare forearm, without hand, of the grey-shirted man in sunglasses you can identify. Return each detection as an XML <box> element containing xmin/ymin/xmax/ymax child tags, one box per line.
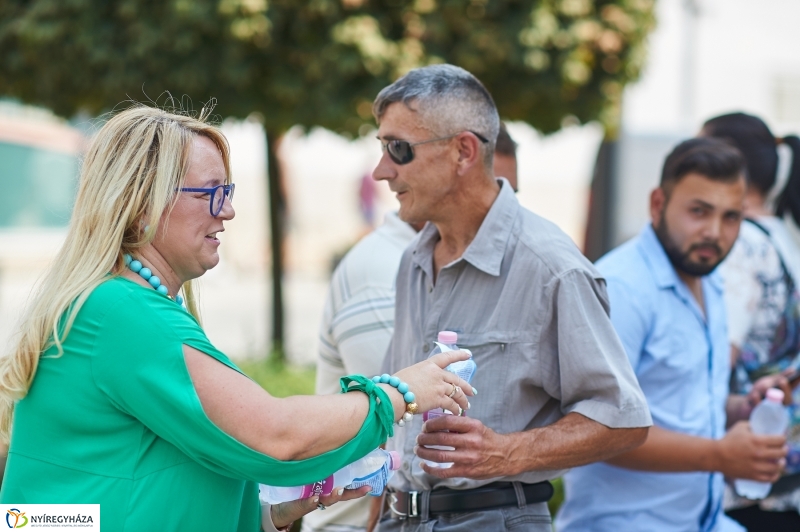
<box><xmin>506</xmin><ymin>412</ymin><xmax>648</xmax><ymax>473</ymax></box>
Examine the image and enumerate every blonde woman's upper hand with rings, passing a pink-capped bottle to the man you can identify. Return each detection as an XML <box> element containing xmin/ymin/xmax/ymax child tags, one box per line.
<box><xmin>387</xmin><ymin>350</ymin><xmax>474</xmax><ymax>418</ymax></box>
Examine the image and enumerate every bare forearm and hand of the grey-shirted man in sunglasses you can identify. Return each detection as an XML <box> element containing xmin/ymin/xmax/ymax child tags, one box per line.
<box><xmin>415</xmin><ymin>413</ymin><xmax>648</xmax><ymax>479</ymax></box>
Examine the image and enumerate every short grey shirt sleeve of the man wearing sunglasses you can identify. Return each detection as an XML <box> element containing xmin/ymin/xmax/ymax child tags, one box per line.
<box><xmin>539</xmin><ymin>270</ymin><xmax>652</xmax><ymax>428</ymax></box>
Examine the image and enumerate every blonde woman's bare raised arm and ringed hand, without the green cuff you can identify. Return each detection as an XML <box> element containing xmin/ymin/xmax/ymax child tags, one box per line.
<box><xmin>183</xmin><ymin>345</ymin><xmax>472</xmax><ymax>461</ymax></box>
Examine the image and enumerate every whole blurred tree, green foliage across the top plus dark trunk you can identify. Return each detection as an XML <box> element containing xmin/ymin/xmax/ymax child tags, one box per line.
<box><xmin>0</xmin><ymin>0</ymin><xmax>654</xmax><ymax>358</ymax></box>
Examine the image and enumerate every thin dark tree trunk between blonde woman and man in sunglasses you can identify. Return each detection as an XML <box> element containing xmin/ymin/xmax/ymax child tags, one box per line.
<box><xmin>265</xmin><ymin>130</ymin><xmax>286</xmax><ymax>362</ymax></box>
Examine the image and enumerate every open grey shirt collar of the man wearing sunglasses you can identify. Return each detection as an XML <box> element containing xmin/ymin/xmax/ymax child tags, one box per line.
<box><xmin>413</xmin><ymin>178</ymin><xmax>519</xmax><ymax>276</ymax></box>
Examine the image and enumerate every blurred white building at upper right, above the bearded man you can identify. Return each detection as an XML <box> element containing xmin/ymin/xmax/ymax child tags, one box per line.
<box><xmin>610</xmin><ymin>0</ymin><xmax>800</xmax><ymax>245</ymax></box>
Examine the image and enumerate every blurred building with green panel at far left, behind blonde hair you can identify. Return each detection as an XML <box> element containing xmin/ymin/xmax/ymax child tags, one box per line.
<box><xmin>0</xmin><ymin>103</ymin><xmax>84</xmax><ymax>354</ymax></box>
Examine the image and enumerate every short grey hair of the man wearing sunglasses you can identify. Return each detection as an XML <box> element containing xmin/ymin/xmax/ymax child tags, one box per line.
<box><xmin>372</xmin><ymin>65</ymin><xmax>500</xmax><ymax>168</ymax></box>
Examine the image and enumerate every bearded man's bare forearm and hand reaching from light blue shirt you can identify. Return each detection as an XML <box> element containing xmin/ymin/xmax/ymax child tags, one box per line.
<box><xmin>607</xmin><ymin>421</ymin><xmax>787</xmax><ymax>482</ymax></box>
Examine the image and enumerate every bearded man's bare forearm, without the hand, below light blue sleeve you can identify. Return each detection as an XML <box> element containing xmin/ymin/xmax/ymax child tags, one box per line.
<box><xmin>606</xmin><ymin>427</ymin><xmax>718</xmax><ymax>472</ymax></box>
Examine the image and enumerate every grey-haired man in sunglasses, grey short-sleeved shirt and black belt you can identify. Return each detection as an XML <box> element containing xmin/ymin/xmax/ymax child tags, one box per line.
<box><xmin>373</xmin><ymin>65</ymin><xmax>651</xmax><ymax>532</ymax></box>
